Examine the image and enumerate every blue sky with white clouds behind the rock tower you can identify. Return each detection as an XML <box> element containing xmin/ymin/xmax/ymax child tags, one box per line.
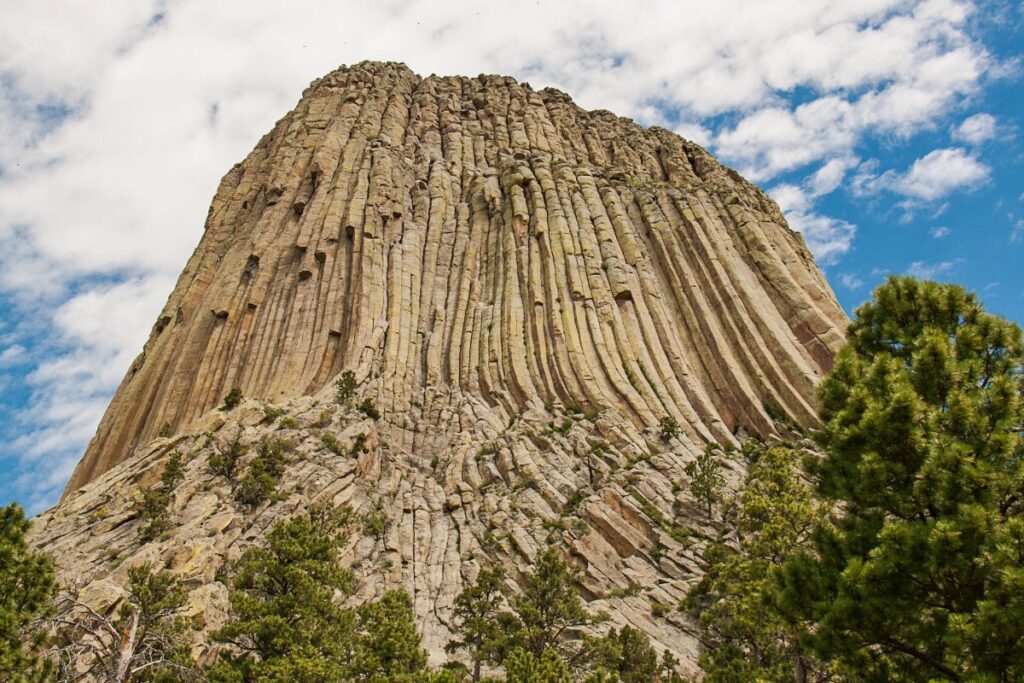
<box><xmin>0</xmin><ymin>0</ymin><xmax>1024</xmax><ymax>512</ymax></box>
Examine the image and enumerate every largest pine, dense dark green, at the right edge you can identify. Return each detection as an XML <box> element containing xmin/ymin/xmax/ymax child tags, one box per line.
<box><xmin>778</xmin><ymin>278</ymin><xmax>1024</xmax><ymax>681</ymax></box>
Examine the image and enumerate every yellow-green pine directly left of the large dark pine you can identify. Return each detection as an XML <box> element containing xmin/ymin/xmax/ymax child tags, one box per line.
<box><xmin>684</xmin><ymin>447</ymin><xmax>825</xmax><ymax>683</ymax></box>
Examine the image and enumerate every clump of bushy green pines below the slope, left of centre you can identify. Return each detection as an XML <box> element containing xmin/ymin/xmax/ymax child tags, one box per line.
<box><xmin>209</xmin><ymin>506</ymin><xmax>438</xmax><ymax>683</ymax></box>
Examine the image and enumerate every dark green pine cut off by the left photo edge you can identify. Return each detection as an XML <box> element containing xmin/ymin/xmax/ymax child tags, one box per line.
<box><xmin>0</xmin><ymin>503</ymin><xmax>56</xmax><ymax>683</ymax></box>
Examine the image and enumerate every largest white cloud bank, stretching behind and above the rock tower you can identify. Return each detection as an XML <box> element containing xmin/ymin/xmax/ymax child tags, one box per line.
<box><xmin>0</xmin><ymin>0</ymin><xmax>998</xmax><ymax>507</ymax></box>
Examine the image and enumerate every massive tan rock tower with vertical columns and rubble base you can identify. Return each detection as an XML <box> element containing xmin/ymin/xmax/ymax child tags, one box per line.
<box><xmin>35</xmin><ymin>62</ymin><xmax>847</xmax><ymax>669</ymax></box>
